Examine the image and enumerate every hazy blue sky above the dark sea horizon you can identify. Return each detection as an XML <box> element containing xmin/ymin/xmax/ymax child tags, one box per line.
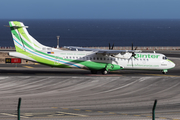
<box><xmin>0</xmin><ymin>0</ymin><xmax>180</xmax><ymax>19</ymax></box>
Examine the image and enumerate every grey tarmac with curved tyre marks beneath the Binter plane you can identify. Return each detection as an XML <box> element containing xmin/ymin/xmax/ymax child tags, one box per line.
<box><xmin>0</xmin><ymin>54</ymin><xmax>180</xmax><ymax>120</ymax></box>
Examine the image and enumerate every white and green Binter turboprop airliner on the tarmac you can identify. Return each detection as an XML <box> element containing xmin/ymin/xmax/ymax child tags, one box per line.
<box><xmin>9</xmin><ymin>21</ymin><xmax>175</xmax><ymax>74</ymax></box>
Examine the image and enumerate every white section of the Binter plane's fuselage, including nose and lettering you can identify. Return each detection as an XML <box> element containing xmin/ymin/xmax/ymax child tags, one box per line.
<box><xmin>50</xmin><ymin>51</ymin><xmax>175</xmax><ymax>70</ymax></box>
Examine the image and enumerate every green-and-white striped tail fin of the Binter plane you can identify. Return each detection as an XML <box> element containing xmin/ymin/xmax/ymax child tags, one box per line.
<box><xmin>9</xmin><ymin>21</ymin><xmax>47</xmax><ymax>52</ymax></box>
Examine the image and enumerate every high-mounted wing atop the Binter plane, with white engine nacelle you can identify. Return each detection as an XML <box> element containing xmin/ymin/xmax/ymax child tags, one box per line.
<box><xmin>64</xmin><ymin>46</ymin><xmax>142</xmax><ymax>58</ymax></box>
